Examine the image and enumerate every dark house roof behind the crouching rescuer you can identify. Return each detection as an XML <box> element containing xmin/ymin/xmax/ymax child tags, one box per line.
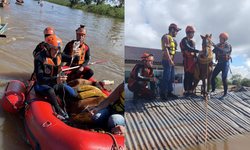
<box><xmin>125</xmin><ymin>46</ymin><xmax>183</xmax><ymax>65</ymax></box>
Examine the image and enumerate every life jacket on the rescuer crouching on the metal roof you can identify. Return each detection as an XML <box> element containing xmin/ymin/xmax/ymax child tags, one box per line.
<box><xmin>128</xmin><ymin>64</ymin><xmax>154</xmax><ymax>87</ymax></box>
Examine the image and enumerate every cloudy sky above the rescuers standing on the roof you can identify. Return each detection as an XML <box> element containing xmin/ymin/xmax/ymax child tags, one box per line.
<box><xmin>125</xmin><ymin>0</ymin><xmax>250</xmax><ymax>79</ymax></box>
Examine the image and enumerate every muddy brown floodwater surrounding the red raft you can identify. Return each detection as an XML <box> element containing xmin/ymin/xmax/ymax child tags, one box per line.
<box><xmin>0</xmin><ymin>0</ymin><xmax>124</xmax><ymax>150</ymax></box>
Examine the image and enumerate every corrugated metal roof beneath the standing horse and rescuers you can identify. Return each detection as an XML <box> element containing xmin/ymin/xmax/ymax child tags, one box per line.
<box><xmin>125</xmin><ymin>91</ymin><xmax>250</xmax><ymax>150</ymax></box>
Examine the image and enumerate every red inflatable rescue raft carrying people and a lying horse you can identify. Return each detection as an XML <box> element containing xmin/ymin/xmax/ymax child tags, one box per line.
<box><xmin>1</xmin><ymin>80</ymin><xmax>125</xmax><ymax>150</ymax></box>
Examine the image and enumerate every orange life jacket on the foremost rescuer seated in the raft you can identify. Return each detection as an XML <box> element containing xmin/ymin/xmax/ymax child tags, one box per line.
<box><xmin>34</xmin><ymin>51</ymin><xmax>62</xmax><ymax>84</ymax></box>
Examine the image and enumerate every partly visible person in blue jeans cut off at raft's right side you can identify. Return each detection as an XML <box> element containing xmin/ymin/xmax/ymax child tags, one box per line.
<box><xmin>89</xmin><ymin>83</ymin><xmax>125</xmax><ymax>134</ymax></box>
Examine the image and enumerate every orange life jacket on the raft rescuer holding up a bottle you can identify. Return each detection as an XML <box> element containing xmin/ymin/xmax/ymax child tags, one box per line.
<box><xmin>68</xmin><ymin>40</ymin><xmax>88</xmax><ymax>66</ymax></box>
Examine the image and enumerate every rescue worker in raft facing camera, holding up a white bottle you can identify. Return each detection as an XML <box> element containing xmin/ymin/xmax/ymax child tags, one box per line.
<box><xmin>63</xmin><ymin>25</ymin><xmax>94</xmax><ymax>80</ymax></box>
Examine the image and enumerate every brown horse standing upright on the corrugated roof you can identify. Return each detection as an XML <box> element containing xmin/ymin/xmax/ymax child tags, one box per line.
<box><xmin>193</xmin><ymin>34</ymin><xmax>214</xmax><ymax>98</ymax></box>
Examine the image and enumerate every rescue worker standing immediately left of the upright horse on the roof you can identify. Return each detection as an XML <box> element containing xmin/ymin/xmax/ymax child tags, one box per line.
<box><xmin>180</xmin><ymin>26</ymin><xmax>202</xmax><ymax>97</ymax></box>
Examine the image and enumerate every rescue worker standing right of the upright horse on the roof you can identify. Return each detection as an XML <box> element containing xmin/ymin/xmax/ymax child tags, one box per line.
<box><xmin>210</xmin><ymin>33</ymin><xmax>232</xmax><ymax>100</ymax></box>
